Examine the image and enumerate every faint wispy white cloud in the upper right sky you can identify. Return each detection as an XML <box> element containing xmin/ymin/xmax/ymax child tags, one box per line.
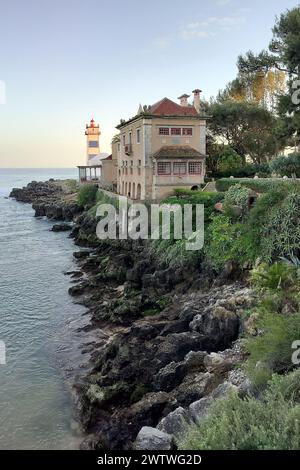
<box><xmin>180</xmin><ymin>15</ymin><xmax>245</xmax><ymax>40</ymax></box>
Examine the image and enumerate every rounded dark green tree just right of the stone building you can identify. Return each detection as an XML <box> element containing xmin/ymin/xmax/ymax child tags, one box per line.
<box><xmin>209</xmin><ymin>101</ymin><xmax>283</xmax><ymax>164</ymax></box>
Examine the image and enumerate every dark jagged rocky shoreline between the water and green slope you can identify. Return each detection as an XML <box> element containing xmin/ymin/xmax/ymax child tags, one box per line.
<box><xmin>11</xmin><ymin>181</ymin><xmax>255</xmax><ymax>450</ymax></box>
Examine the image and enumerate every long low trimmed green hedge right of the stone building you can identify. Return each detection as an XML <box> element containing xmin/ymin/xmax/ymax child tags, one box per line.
<box><xmin>216</xmin><ymin>178</ymin><xmax>300</xmax><ymax>193</ymax></box>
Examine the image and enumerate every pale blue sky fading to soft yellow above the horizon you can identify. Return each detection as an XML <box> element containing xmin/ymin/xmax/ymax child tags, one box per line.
<box><xmin>0</xmin><ymin>0</ymin><xmax>298</xmax><ymax>168</ymax></box>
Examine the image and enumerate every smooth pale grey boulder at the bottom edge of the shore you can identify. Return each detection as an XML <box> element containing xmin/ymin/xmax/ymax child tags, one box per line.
<box><xmin>133</xmin><ymin>426</ymin><xmax>174</xmax><ymax>450</ymax></box>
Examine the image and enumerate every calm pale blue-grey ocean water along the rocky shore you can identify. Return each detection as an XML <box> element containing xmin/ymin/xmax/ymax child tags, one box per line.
<box><xmin>0</xmin><ymin>169</ymin><xmax>87</xmax><ymax>449</ymax></box>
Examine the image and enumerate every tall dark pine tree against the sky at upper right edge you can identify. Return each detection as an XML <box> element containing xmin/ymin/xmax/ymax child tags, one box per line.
<box><xmin>238</xmin><ymin>6</ymin><xmax>300</xmax><ymax>151</ymax></box>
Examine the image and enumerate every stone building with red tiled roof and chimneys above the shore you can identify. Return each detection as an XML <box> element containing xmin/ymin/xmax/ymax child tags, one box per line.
<box><xmin>112</xmin><ymin>89</ymin><xmax>207</xmax><ymax>200</ymax></box>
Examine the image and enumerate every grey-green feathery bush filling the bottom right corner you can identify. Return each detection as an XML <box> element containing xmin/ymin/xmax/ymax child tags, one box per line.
<box><xmin>179</xmin><ymin>370</ymin><xmax>300</xmax><ymax>450</ymax></box>
